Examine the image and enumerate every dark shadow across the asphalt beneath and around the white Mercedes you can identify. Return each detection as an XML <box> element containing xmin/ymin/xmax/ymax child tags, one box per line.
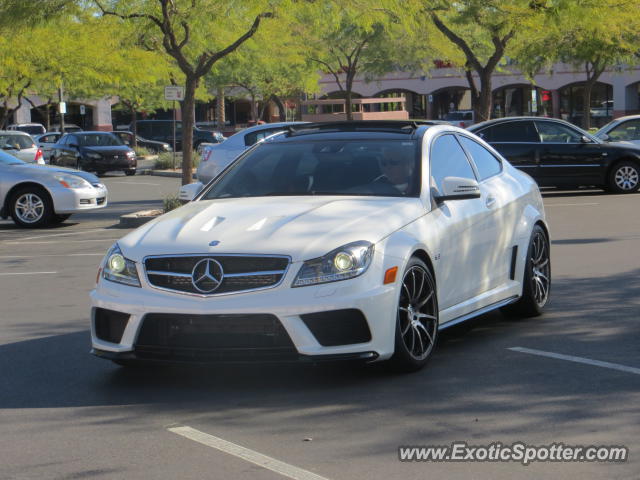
<box><xmin>0</xmin><ymin>270</ymin><xmax>640</xmax><ymax>438</ymax></box>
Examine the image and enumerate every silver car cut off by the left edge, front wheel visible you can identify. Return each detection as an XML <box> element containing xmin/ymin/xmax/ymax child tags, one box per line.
<box><xmin>0</xmin><ymin>152</ymin><xmax>107</xmax><ymax>228</ymax></box>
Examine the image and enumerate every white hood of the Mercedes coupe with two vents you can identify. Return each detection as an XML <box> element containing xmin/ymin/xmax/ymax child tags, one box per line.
<box><xmin>118</xmin><ymin>196</ymin><xmax>425</xmax><ymax>262</ymax></box>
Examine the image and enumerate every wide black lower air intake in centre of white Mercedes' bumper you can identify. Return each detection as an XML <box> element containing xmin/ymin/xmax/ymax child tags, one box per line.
<box><xmin>135</xmin><ymin>313</ymin><xmax>297</xmax><ymax>361</ymax></box>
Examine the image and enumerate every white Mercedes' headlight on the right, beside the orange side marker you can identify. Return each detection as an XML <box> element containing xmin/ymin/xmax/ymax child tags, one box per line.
<box><xmin>291</xmin><ymin>241</ymin><xmax>374</xmax><ymax>287</ymax></box>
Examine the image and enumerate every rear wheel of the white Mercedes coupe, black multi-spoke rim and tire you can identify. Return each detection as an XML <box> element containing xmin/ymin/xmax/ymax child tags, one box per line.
<box><xmin>502</xmin><ymin>225</ymin><xmax>551</xmax><ymax>317</ymax></box>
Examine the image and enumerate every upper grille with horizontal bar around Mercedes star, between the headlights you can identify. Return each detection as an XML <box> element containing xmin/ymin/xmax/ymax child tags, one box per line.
<box><xmin>144</xmin><ymin>255</ymin><xmax>290</xmax><ymax>295</ymax></box>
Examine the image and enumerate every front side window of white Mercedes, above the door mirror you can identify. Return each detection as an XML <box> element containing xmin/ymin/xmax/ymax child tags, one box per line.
<box><xmin>431</xmin><ymin>135</ymin><xmax>476</xmax><ymax>192</ymax></box>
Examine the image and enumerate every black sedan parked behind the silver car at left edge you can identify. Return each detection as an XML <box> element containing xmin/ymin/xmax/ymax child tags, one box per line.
<box><xmin>51</xmin><ymin>132</ymin><xmax>136</xmax><ymax>175</ymax></box>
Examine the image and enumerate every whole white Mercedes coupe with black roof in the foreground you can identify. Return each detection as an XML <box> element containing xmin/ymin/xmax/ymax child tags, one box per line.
<box><xmin>91</xmin><ymin>121</ymin><xmax>551</xmax><ymax>371</ymax></box>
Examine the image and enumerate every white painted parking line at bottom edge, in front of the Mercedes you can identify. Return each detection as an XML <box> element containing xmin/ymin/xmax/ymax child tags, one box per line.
<box><xmin>167</xmin><ymin>426</ymin><xmax>327</xmax><ymax>480</ymax></box>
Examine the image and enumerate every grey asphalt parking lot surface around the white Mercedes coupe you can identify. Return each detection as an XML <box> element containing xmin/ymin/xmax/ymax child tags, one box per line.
<box><xmin>0</xmin><ymin>175</ymin><xmax>640</xmax><ymax>480</ymax></box>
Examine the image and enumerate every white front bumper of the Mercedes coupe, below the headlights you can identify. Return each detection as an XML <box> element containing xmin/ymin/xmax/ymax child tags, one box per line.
<box><xmin>91</xmin><ymin>255</ymin><xmax>399</xmax><ymax>363</ymax></box>
